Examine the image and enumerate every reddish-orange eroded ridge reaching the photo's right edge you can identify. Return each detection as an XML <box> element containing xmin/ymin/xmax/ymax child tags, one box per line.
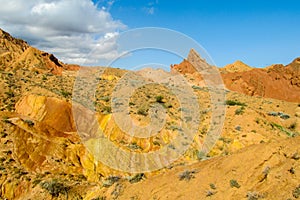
<box><xmin>222</xmin><ymin>63</ymin><xmax>300</xmax><ymax>102</ymax></box>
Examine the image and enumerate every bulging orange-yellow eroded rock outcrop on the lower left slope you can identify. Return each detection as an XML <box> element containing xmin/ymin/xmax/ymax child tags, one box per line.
<box><xmin>5</xmin><ymin>95</ymin><xmax>118</xmax><ymax>195</ymax></box>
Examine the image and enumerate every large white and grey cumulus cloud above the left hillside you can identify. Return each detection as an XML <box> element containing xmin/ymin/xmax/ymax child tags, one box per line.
<box><xmin>0</xmin><ymin>0</ymin><xmax>126</xmax><ymax>64</ymax></box>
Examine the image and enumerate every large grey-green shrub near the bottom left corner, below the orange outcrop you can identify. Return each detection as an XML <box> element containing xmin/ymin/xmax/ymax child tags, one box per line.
<box><xmin>40</xmin><ymin>180</ymin><xmax>70</xmax><ymax>197</ymax></box>
